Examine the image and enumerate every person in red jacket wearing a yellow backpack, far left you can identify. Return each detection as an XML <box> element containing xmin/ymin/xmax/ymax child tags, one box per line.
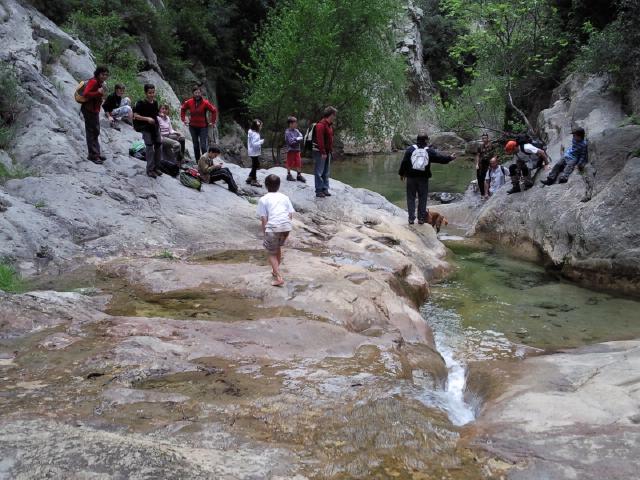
<box><xmin>80</xmin><ymin>67</ymin><xmax>109</xmax><ymax>165</ymax></box>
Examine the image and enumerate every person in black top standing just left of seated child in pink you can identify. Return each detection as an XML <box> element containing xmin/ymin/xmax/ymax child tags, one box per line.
<box><xmin>133</xmin><ymin>83</ymin><xmax>162</xmax><ymax>178</ymax></box>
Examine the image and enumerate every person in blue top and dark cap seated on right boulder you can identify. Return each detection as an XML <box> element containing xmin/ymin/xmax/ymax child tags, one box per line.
<box><xmin>541</xmin><ymin>128</ymin><xmax>596</xmax><ymax>202</ymax></box>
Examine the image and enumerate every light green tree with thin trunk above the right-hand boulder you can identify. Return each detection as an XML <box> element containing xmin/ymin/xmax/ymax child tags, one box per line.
<box><xmin>442</xmin><ymin>0</ymin><xmax>568</xmax><ymax>130</ymax></box>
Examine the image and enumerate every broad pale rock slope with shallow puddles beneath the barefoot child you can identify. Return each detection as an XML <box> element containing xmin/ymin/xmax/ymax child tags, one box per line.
<box><xmin>0</xmin><ymin>0</ymin><xmax>475</xmax><ymax>478</ymax></box>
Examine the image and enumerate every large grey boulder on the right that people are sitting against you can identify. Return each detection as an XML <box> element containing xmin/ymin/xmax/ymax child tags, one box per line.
<box><xmin>475</xmin><ymin>73</ymin><xmax>640</xmax><ymax>293</ymax></box>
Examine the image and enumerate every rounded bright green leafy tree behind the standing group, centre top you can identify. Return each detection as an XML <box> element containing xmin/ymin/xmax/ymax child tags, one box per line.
<box><xmin>245</xmin><ymin>0</ymin><xmax>407</xmax><ymax>139</ymax></box>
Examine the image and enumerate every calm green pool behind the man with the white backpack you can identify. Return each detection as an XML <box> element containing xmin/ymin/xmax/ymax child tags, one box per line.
<box><xmin>331</xmin><ymin>153</ymin><xmax>475</xmax><ymax>207</ymax></box>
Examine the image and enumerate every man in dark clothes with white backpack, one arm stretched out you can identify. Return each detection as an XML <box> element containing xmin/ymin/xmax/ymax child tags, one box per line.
<box><xmin>398</xmin><ymin>133</ymin><xmax>456</xmax><ymax>225</ymax></box>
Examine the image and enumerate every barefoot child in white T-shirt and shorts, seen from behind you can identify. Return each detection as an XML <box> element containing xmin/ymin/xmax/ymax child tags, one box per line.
<box><xmin>258</xmin><ymin>174</ymin><xmax>295</xmax><ymax>287</ymax></box>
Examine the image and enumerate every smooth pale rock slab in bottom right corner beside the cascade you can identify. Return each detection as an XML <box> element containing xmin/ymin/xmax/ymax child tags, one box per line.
<box><xmin>475</xmin><ymin>341</ymin><xmax>640</xmax><ymax>480</ymax></box>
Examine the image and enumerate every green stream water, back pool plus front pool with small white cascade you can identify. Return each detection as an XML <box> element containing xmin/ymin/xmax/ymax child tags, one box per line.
<box><xmin>332</xmin><ymin>153</ymin><xmax>640</xmax><ymax>425</ymax></box>
